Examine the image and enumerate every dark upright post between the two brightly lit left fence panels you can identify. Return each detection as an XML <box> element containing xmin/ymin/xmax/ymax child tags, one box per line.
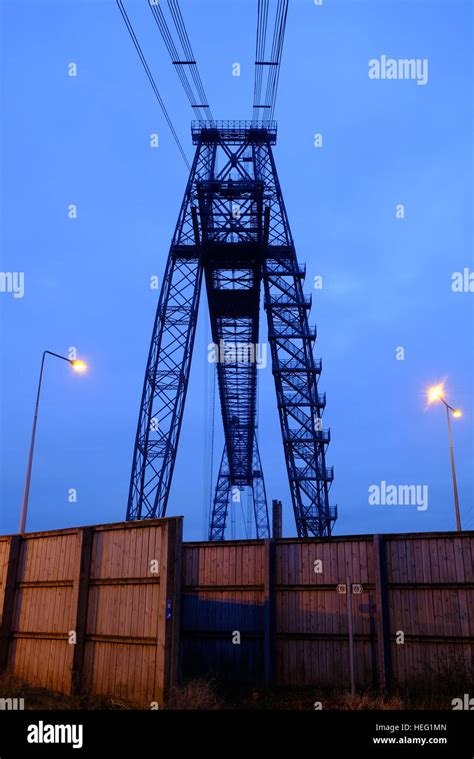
<box><xmin>71</xmin><ymin>527</ymin><xmax>93</xmax><ymax>693</ymax></box>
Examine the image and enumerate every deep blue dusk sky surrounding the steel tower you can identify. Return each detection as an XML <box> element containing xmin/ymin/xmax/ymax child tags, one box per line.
<box><xmin>0</xmin><ymin>0</ymin><xmax>474</xmax><ymax>540</ymax></box>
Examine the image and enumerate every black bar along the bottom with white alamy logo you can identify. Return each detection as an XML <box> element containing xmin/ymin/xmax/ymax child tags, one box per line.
<box><xmin>0</xmin><ymin>712</ymin><xmax>474</xmax><ymax>759</ymax></box>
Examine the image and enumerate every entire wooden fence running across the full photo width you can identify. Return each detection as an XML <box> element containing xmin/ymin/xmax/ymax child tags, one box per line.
<box><xmin>0</xmin><ymin>519</ymin><xmax>474</xmax><ymax>705</ymax></box>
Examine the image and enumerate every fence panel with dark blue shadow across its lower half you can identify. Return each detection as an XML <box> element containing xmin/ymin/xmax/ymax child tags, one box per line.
<box><xmin>181</xmin><ymin>540</ymin><xmax>268</xmax><ymax>682</ymax></box>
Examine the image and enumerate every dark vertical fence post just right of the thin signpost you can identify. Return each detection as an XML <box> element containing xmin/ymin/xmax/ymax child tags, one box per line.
<box><xmin>373</xmin><ymin>535</ymin><xmax>392</xmax><ymax>691</ymax></box>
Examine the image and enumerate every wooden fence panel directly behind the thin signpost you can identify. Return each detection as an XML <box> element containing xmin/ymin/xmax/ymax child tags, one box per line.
<box><xmin>276</xmin><ymin>538</ymin><xmax>376</xmax><ymax>685</ymax></box>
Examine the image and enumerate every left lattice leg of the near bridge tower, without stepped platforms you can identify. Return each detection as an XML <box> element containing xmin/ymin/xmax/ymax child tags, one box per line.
<box><xmin>127</xmin><ymin>145</ymin><xmax>213</xmax><ymax>520</ymax></box>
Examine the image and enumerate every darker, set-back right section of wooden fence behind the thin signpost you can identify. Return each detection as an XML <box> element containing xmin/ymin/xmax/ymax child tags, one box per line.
<box><xmin>181</xmin><ymin>532</ymin><xmax>474</xmax><ymax>687</ymax></box>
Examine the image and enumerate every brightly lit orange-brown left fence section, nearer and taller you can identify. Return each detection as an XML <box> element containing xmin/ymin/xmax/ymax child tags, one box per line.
<box><xmin>0</xmin><ymin>519</ymin><xmax>182</xmax><ymax>705</ymax></box>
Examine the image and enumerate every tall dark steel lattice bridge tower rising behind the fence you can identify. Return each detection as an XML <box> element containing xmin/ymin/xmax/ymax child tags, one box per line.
<box><xmin>127</xmin><ymin>121</ymin><xmax>337</xmax><ymax>540</ymax></box>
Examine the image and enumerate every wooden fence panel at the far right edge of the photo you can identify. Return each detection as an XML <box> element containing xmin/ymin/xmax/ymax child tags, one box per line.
<box><xmin>386</xmin><ymin>533</ymin><xmax>474</xmax><ymax>684</ymax></box>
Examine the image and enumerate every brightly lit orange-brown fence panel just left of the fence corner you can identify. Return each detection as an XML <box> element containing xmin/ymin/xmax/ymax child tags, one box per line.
<box><xmin>84</xmin><ymin>524</ymin><xmax>174</xmax><ymax>704</ymax></box>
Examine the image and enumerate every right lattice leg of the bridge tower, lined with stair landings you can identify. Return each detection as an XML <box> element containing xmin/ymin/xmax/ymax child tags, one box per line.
<box><xmin>254</xmin><ymin>144</ymin><xmax>337</xmax><ymax>537</ymax></box>
